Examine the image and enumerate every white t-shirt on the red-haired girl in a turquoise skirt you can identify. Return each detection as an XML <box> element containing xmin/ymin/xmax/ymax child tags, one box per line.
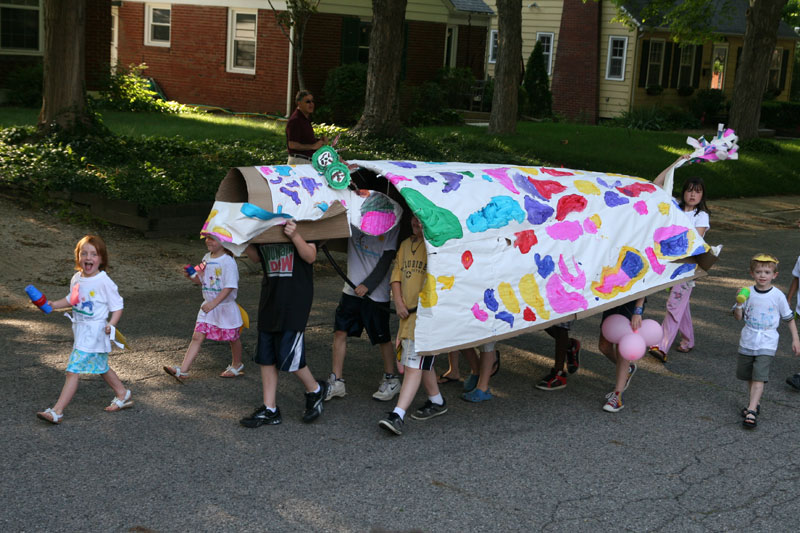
<box><xmin>66</xmin><ymin>271</ymin><xmax>122</xmax><ymax>353</ymax></box>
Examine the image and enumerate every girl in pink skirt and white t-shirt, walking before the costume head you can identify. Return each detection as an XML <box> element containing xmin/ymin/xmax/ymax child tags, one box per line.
<box><xmin>164</xmin><ymin>236</ymin><xmax>244</xmax><ymax>382</ymax></box>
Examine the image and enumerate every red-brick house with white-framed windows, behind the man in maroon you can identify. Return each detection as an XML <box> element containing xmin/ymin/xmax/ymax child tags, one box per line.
<box><xmin>112</xmin><ymin>0</ymin><xmax>492</xmax><ymax>114</ymax></box>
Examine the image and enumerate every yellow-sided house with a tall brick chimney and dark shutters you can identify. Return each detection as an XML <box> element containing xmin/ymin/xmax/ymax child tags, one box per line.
<box><xmin>487</xmin><ymin>0</ymin><xmax>800</xmax><ymax>123</ymax></box>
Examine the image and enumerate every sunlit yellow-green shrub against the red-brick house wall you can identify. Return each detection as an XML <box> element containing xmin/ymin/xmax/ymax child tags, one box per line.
<box><xmin>99</xmin><ymin>63</ymin><xmax>200</xmax><ymax>113</ymax></box>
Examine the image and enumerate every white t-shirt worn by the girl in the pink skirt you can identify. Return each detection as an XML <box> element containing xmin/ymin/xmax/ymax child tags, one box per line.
<box><xmin>197</xmin><ymin>249</ymin><xmax>242</xmax><ymax>329</ymax></box>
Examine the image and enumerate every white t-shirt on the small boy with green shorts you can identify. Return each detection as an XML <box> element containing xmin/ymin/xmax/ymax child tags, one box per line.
<box><xmin>739</xmin><ymin>286</ymin><xmax>793</xmax><ymax>355</ymax></box>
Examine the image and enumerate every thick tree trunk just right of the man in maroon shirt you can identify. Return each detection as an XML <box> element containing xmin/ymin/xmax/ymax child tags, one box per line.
<box><xmin>353</xmin><ymin>0</ymin><xmax>406</xmax><ymax>137</ymax></box>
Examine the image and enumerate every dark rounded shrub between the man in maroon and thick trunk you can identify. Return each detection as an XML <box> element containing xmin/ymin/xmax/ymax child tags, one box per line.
<box><xmin>323</xmin><ymin>63</ymin><xmax>367</xmax><ymax>126</ymax></box>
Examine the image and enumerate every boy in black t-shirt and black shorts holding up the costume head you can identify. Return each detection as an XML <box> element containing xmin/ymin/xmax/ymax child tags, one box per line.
<box><xmin>239</xmin><ymin>220</ymin><xmax>328</xmax><ymax>428</ymax></box>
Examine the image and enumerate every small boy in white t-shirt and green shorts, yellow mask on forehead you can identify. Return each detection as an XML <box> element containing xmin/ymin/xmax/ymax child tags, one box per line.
<box><xmin>733</xmin><ymin>254</ymin><xmax>800</xmax><ymax>429</ymax></box>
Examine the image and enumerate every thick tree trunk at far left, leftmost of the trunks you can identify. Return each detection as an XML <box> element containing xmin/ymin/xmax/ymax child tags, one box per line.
<box><xmin>38</xmin><ymin>0</ymin><xmax>92</xmax><ymax>133</ymax></box>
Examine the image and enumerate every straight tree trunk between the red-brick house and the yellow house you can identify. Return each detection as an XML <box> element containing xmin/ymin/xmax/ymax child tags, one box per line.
<box><xmin>489</xmin><ymin>0</ymin><xmax>522</xmax><ymax>134</ymax></box>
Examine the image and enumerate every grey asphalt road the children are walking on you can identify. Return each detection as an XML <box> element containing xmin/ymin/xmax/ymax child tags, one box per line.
<box><xmin>0</xmin><ymin>197</ymin><xmax>800</xmax><ymax>533</ymax></box>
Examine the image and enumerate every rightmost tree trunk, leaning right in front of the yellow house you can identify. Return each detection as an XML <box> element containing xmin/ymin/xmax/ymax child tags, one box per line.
<box><xmin>728</xmin><ymin>0</ymin><xmax>788</xmax><ymax>139</ymax></box>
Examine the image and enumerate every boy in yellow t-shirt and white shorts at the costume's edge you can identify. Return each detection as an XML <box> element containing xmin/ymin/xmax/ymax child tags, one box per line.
<box><xmin>378</xmin><ymin>217</ymin><xmax>447</xmax><ymax>435</ymax></box>
